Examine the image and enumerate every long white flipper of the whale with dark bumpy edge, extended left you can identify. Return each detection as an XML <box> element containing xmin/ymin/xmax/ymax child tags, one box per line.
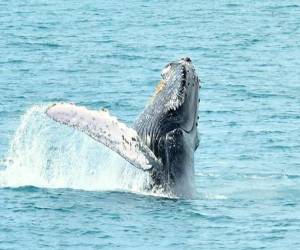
<box><xmin>46</xmin><ymin>103</ymin><xmax>161</xmax><ymax>170</ymax></box>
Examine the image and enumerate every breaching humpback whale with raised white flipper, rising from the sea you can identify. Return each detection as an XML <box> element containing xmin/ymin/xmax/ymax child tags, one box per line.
<box><xmin>46</xmin><ymin>57</ymin><xmax>200</xmax><ymax>196</ymax></box>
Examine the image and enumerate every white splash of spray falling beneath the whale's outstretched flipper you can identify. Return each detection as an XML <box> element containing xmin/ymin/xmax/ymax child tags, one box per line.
<box><xmin>0</xmin><ymin>106</ymin><xmax>150</xmax><ymax>193</ymax></box>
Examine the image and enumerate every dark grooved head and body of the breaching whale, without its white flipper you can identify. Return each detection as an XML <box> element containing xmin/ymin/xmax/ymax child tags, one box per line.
<box><xmin>134</xmin><ymin>58</ymin><xmax>200</xmax><ymax>196</ymax></box>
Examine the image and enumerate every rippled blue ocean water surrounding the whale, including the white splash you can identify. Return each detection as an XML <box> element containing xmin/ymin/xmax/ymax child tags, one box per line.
<box><xmin>0</xmin><ymin>0</ymin><xmax>300</xmax><ymax>250</ymax></box>
